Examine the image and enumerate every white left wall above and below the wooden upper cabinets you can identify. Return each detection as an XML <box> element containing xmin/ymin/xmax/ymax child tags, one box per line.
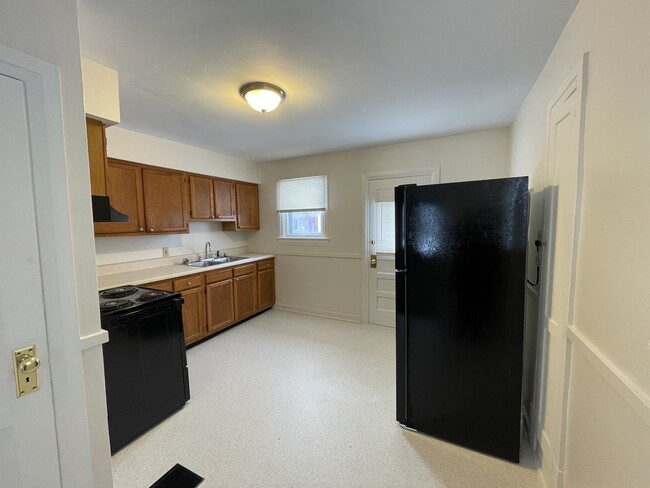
<box><xmin>95</xmin><ymin>126</ymin><xmax>259</xmax><ymax>265</ymax></box>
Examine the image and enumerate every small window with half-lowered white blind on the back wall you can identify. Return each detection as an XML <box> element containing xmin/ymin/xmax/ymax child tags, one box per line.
<box><xmin>277</xmin><ymin>175</ymin><xmax>327</xmax><ymax>239</ymax></box>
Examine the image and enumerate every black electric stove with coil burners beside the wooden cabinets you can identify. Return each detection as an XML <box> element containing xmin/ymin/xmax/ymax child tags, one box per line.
<box><xmin>99</xmin><ymin>286</ymin><xmax>190</xmax><ymax>453</ymax></box>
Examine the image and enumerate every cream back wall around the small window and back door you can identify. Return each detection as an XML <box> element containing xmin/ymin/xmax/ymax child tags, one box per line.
<box><xmin>248</xmin><ymin>129</ymin><xmax>511</xmax><ymax>321</ymax></box>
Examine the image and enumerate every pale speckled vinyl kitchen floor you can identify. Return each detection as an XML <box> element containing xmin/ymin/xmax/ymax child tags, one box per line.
<box><xmin>113</xmin><ymin>310</ymin><xmax>541</xmax><ymax>488</ymax></box>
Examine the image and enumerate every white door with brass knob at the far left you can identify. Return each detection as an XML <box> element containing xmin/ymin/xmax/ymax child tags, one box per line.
<box><xmin>0</xmin><ymin>71</ymin><xmax>60</xmax><ymax>488</ymax></box>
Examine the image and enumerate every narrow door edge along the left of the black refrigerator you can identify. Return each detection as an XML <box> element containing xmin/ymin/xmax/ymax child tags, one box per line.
<box><xmin>395</xmin><ymin>186</ymin><xmax>408</xmax><ymax>425</ymax></box>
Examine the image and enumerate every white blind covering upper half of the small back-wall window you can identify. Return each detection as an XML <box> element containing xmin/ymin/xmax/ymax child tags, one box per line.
<box><xmin>277</xmin><ymin>175</ymin><xmax>327</xmax><ymax>212</ymax></box>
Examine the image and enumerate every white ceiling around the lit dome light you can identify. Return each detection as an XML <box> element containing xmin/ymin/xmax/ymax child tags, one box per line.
<box><xmin>79</xmin><ymin>0</ymin><xmax>578</xmax><ymax>161</ymax></box>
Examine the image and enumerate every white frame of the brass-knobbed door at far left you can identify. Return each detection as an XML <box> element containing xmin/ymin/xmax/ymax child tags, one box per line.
<box><xmin>0</xmin><ymin>45</ymin><xmax>100</xmax><ymax>486</ymax></box>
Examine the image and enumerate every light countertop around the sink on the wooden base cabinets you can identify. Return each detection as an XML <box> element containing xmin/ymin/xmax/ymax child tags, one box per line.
<box><xmin>97</xmin><ymin>253</ymin><xmax>275</xmax><ymax>291</ymax></box>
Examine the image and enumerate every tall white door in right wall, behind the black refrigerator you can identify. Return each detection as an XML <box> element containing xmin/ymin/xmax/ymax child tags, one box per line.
<box><xmin>539</xmin><ymin>60</ymin><xmax>582</xmax><ymax>487</ymax></box>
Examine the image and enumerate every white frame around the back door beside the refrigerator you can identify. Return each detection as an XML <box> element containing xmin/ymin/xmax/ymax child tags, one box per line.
<box><xmin>361</xmin><ymin>166</ymin><xmax>440</xmax><ymax>324</ymax></box>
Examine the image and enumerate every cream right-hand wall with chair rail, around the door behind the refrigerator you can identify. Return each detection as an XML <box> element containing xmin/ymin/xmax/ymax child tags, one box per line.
<box><xmin>512</xmin><ymin>0</ymin><xmax>650</xmax><ymax>488</ymax></box>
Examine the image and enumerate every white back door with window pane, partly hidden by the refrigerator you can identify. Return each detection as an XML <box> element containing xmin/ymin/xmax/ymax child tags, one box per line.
<box><xmin>366</xmin><ymin>174</ymin><xmax>431</xmax><ymax>327</ymax></box>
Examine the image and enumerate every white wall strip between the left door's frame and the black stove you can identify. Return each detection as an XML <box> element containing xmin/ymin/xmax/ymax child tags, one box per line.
<box><xmin>0</xmin><ymin>0</ymin><xmax>112</xmax><ymax>488</ymax></box>
